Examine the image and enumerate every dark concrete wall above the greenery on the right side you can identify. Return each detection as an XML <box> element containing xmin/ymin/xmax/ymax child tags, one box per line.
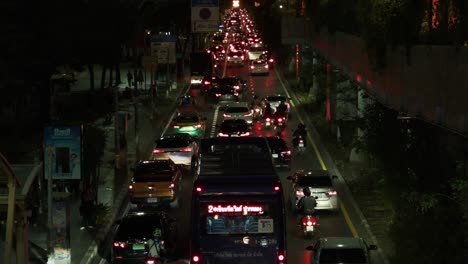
<box><xmin>313</xmin><ymin>30</ymin><xmax>468</xmax><ymax>134</ymax></box>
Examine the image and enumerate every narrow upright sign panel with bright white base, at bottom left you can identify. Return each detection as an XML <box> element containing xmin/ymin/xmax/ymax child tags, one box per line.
<box><xmin>51</xmin><ymin>197</ymin><xmax>71</xmax><ymax>264</ymax></box>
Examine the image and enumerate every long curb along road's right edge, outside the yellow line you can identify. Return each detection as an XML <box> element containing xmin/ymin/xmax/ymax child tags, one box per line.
<box><xmin>275</xmin><ymin>69</ymin><xmax>390</xmax><ymax>264</ymax></box>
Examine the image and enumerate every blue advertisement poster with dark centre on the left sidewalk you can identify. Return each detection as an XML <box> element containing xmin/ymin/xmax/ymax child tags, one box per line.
<box><xmin>44</xmin><ymin>126</ymin><xmax>81</xmax><ymax>180</ymax></box>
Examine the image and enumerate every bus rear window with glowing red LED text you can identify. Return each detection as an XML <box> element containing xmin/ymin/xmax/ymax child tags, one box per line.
<box><xmin>200</xmin><ymin>202</ymin><xmax>276</xmax><ymax>235</ymax></box>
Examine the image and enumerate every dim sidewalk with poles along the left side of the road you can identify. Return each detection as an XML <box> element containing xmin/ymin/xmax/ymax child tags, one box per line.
<box><xmin>6</xmin><ymin>65</ymin><xmax>188</xmax><ymax>264</ymax></box>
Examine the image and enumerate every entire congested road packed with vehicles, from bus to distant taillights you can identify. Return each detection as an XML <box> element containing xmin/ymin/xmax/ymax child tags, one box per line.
<box><xmin>100</xmin><ymin>6</ymin><xmax>384</xmax><ymax>264</ymax></box>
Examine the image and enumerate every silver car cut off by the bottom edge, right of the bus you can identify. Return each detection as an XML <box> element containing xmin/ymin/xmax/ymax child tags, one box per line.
<box><xmin>306</xmin><ymin>237</ymin><xmax>377</xmax><ymax>264</ymax></box>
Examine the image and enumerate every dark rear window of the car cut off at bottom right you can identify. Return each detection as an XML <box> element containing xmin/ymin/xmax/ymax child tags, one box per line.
<box><xmin>320</xmin><ymin>248</ymin><xmax>367</xmax><ymax>263</ymax></box>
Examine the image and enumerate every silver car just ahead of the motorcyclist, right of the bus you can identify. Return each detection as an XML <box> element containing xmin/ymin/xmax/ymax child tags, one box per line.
<box><xmin>287</xmin><ymin>170</ymin><xmax>339</xmax><ymax>211</ymax></box>
